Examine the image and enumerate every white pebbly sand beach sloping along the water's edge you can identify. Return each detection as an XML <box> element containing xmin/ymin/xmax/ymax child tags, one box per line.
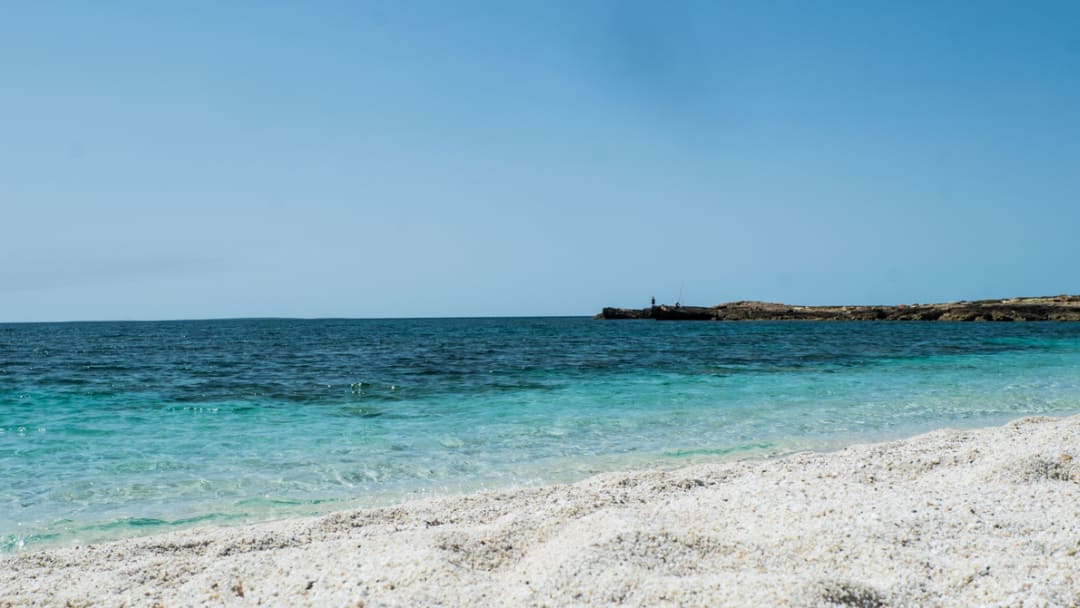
<box><xmin>0</xmin><ymin>416</ymin><xmax>1080</xmax><ymax>607</ymax></box>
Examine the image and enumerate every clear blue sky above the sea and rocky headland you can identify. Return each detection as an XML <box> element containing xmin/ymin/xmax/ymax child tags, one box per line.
<box><xmin>0</xmin><ymin>0</ymin><xmax>1080</xmax><ymax>322</ymax></box>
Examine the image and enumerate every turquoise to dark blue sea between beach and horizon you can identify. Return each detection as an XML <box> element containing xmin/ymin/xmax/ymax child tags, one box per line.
<box><xmin>0</xmin><ymin>317</ymin><xmax>1080</xmax><ymax>552</ymax></box>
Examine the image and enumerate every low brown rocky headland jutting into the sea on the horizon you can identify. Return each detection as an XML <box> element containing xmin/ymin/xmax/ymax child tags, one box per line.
<box><xmin>594</xmin><ymin>296</ymin><xmax>1080</xmax><ymax>321</ymax></box>
